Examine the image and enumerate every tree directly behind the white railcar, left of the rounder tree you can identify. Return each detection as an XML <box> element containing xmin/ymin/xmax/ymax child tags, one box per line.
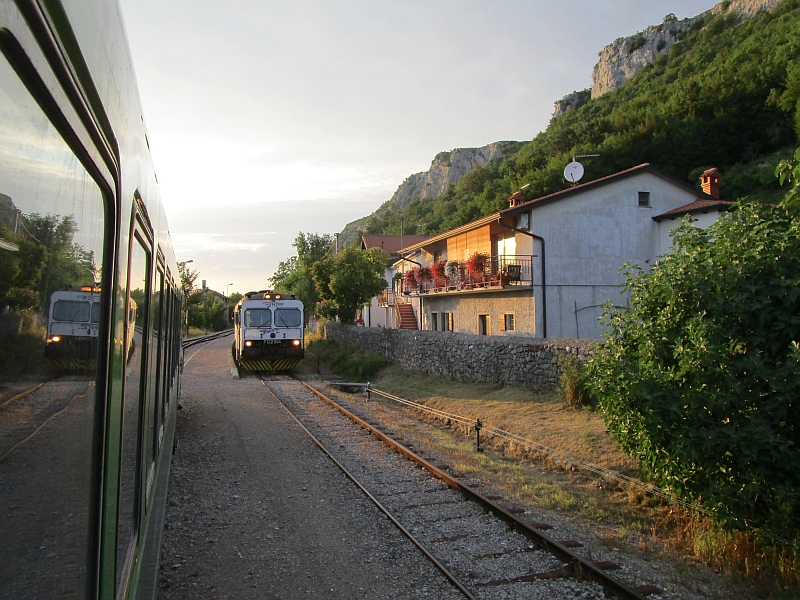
<box><xmin>270</xmin><ymin>232</ymin><xmax>334</xmax><ymax>315</ymax></box>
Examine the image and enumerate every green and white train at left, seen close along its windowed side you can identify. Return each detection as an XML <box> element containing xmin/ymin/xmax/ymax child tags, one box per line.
<box><xmin>0</xmin><ymin>0</ymin><xmax>185</xmax><ymax>600</ymax></box>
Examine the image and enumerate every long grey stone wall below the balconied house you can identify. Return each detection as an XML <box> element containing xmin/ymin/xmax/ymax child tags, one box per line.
<box><xmin>326</xmin><ymin>322</ymin><xmax>596</xmax><ymax>392</ymax></box>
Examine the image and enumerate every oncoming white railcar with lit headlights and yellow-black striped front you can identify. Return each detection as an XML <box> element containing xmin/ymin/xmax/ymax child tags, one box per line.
<box><xmin>233</xmin><ymin>290</ymin><xmax>305</xmax><ymax>373</ymax></box>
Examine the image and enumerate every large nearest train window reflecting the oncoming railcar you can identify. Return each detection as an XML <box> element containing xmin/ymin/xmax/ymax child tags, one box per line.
<box><xmin>0</xmin><ymin>54</ymin><xmax>105</xmax><ymax>598</ymax></box>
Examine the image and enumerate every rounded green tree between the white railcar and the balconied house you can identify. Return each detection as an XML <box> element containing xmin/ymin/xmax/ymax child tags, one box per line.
<box><xmin>312</xmin><ymin>246</ymin><xmax>389</xmax><ymax>323</ymax></box>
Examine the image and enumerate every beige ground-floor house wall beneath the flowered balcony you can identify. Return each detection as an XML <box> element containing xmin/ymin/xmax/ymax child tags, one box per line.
<box><xmin>423</xmin><ymin>288</ymin><xmax>536</xmax><ymax>336</ymax></box>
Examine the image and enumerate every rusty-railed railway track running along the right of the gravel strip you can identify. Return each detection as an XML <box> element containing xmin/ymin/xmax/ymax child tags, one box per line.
<box><xmin>261</xmin><ymin>377</ymin><xmax>661</xmax><ymax>600</ymax></box>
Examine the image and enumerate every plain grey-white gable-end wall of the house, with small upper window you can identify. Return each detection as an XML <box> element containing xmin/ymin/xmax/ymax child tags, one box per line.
<box><xmin>530</xmin><ymin>172</ymin><xmax>697</xmax><ymax>339</ymax></box>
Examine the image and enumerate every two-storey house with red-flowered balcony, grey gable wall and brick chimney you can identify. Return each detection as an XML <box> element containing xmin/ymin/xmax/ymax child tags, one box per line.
<box><xmin>394</xmin><ymin>164</ymin><xmax>733</xmax><ymax>339</ymax></box>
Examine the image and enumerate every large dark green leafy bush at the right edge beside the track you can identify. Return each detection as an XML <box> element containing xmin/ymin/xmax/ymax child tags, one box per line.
<box><xmin>588</xmin><ymin>204</ymin><xmax>800</xmax><ymax>537</ymax></box>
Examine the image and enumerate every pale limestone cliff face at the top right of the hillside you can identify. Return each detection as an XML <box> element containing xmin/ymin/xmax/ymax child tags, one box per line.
<box><xmin>592</xmin><ymin>0</ymin><xmax>782</xmax><ymax>98</ymax></box>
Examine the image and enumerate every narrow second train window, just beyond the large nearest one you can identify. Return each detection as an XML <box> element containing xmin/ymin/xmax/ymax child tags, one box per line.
<box><xmin>117</xmin><ymin>235</ymin><xmax>151</xmax><ymax>589</ymax></box>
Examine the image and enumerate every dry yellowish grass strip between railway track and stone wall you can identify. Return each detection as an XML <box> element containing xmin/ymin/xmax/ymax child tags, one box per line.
<box><xmin>304</xmin><ymin>350</ymin><xmax>800</xmax><ymax>599</ymax></box>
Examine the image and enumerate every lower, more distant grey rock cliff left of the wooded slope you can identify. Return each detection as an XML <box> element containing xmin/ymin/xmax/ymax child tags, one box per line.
<box><xmin>339</xmin><ymin>142</ymin><xmax>509</xmax><ymax>245</ymax></box>
